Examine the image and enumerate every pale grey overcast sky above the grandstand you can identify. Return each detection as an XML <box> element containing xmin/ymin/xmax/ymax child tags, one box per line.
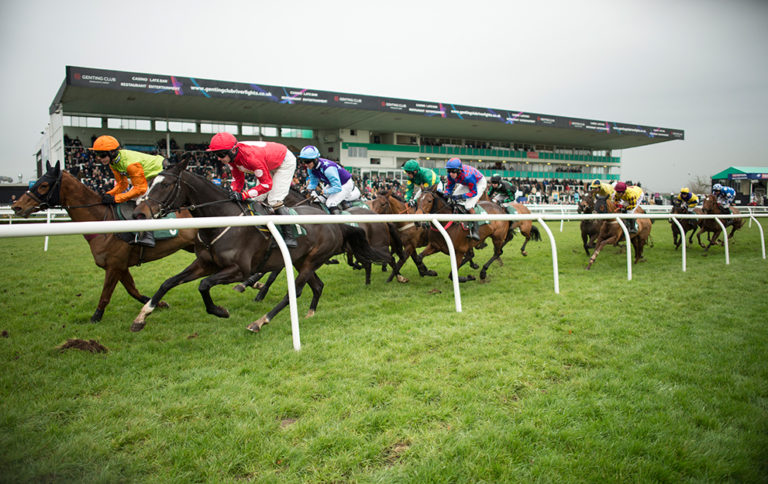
<box><xmin>0</xmin><ymin>0</ymin><xmax>768</xmax><ymax>192</ymax></box>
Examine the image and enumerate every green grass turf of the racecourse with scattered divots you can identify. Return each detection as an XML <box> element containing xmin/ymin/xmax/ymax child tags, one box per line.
<box><xmin>0</xmin><ymin>221</ymin><xmax>768</xmax><ymax>483</ymax></box>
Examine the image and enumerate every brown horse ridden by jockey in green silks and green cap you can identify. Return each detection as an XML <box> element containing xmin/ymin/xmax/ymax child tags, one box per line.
<box><xmin>371</xmin><ymin>190</ymin><xmax>437</xmax><ymax>281</ymax></box>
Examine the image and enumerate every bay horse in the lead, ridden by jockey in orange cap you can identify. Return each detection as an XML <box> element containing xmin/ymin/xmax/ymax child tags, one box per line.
<box><xmin>12</xmin><ymin>162</ymin><xmax>197</xmax><ymax>323</ymax></box>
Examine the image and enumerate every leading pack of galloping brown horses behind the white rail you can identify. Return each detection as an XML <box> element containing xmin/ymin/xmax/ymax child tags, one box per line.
<box><xmin>13</xmin><ymin>161</ymin><xmax>541</xmax><ymax>332</ymax></box>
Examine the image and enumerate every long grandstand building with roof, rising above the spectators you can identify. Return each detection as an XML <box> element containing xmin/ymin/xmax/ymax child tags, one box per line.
<box><xmin>36</xmin><ymin>66</ymin><xmax>684</xmax><ymax>195</ymax></box>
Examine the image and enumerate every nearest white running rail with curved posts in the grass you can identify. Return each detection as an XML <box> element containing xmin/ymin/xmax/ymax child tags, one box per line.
<box><xmin>0</xmin><ymin>209</ymin><xmax>768</xmax><ymax>351</ymax></box>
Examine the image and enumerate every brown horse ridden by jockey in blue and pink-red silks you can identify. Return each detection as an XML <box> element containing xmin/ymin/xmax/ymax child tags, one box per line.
<box><xmin>416</xmin><ymin>191</ymin><xmax>513</xmax><ymax>282</ymax></box>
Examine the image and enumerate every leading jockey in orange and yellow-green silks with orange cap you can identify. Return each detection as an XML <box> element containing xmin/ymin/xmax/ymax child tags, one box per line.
<box><xmin>89</xmin><ymin>136</ymin><xmax>165</xmax><ymax>247</ymax></box>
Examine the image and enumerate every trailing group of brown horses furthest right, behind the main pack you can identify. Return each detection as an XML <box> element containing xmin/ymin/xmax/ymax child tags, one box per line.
<box><xmin>577</xmin><ymin>194</ymin><xmax>743</xmax><ymax>269</ymax></box>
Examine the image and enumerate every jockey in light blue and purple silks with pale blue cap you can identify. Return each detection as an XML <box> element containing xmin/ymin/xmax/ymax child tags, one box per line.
<box><xmin>299</xmin><ymin>145</ymin><xmax>360</xmax><ymax>214</ymax></box>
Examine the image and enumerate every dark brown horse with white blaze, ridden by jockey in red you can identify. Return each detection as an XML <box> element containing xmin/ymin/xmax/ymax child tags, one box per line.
<box><xmin>131</xmin><ymin>160</ymin><xmax>390</xmax><ymax>332</ymax></box>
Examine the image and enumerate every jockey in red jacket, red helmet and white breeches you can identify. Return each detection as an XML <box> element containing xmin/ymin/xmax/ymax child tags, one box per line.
<box><xmin>206</xmin><ymin>132</ymin><xmax>297</xmax><ymax>247</ymax></box>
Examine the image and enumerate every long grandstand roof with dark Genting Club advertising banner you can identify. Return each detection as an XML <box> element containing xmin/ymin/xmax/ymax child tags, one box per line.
<box><xmin>50</xmin><ymin>66</ymin><xmax>685</xmax><ymax>150</ymax></box>
